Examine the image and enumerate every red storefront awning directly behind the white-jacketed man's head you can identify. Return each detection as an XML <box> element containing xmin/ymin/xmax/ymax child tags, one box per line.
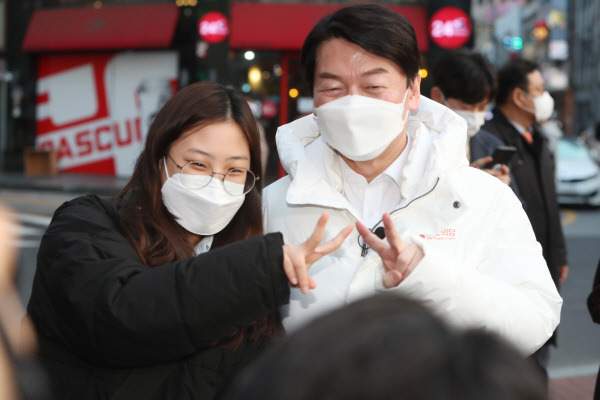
<box><xmin>229</xmin><ymin>2</ymin><xmax>429</xmax><ymax>52</ymax></box>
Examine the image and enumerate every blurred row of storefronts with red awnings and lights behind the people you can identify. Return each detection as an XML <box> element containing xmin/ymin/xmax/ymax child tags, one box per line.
<box><xmin>0</xmin><ymin>0</ymin><xmax>600</xmax><ymax>180</ymax></box>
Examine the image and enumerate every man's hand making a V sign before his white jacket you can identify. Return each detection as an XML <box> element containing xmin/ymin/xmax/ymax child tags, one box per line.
<box><xmin>356</xmin><ymin>213</ymin><xmax>425</xmax><ymax>289</ymax></box>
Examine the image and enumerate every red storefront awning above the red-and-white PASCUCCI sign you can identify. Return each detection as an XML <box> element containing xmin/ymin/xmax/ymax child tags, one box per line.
<box><xmin>23</xmin><ymin>3</ymin><xmax>179</xmax><ymax>52</ymax></box>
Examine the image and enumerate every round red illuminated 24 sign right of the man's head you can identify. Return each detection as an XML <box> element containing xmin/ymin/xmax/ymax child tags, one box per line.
<box><xmin>429</xmin><ymin>7</ymin><xmax>472</xmax><ymax>49</ymax></box>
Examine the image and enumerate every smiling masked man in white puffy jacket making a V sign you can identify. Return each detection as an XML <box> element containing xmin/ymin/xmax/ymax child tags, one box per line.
<box><xmin>264</xmin><ymin>4</ymin><xmax>562</xmax><ymax>354</ymax></box>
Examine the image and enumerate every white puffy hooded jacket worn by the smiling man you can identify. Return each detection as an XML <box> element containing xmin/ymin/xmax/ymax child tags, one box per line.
<box><xmin>264</xmin><ymin>97</ymin><xmax>562</xmax><ymax>354</ymax></box>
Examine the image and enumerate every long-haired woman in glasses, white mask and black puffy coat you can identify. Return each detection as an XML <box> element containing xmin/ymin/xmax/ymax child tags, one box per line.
<box><xmin>28</xmin><ymin>82</ymin><xmax>352</xmax><ymax>400</ymax></box>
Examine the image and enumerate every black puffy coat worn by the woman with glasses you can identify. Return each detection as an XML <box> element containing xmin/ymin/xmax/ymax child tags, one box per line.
<box><xmin>27</xmin><ymin>195</ymin><xmax>289</xmax><ymax>400</ymax></box>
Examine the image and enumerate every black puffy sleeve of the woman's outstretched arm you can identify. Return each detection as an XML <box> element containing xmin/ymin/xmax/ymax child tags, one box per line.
<box><xmin>28</xmin><ymin>195</ymin><xmax>289</xmax><ymax>366</ymax></box>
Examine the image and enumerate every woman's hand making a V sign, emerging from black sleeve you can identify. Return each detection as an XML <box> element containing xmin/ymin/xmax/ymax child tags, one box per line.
<box><xmin>283</xmin><ymin>212</ymin><xmax>353</xmax><ymax>294</ymax></box>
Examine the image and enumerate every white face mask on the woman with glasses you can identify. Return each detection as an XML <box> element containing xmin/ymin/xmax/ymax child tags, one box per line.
<box><xmin>161</xmin><ymin>160</ymin><xmax>246</xmax><ymax>235</ymax></box>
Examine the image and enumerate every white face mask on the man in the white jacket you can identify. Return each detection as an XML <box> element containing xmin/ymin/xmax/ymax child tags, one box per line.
<box><xmin>315</xmin><ymin>89</ymin><xmax>408</xmax><ymax>161</ymax></box>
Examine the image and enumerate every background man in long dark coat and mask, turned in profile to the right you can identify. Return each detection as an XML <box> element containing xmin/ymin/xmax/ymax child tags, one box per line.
<box><xmin>473</xmin><ymin>59</ymin><xmax>569</xmax><ymax>382</ymax></box>
